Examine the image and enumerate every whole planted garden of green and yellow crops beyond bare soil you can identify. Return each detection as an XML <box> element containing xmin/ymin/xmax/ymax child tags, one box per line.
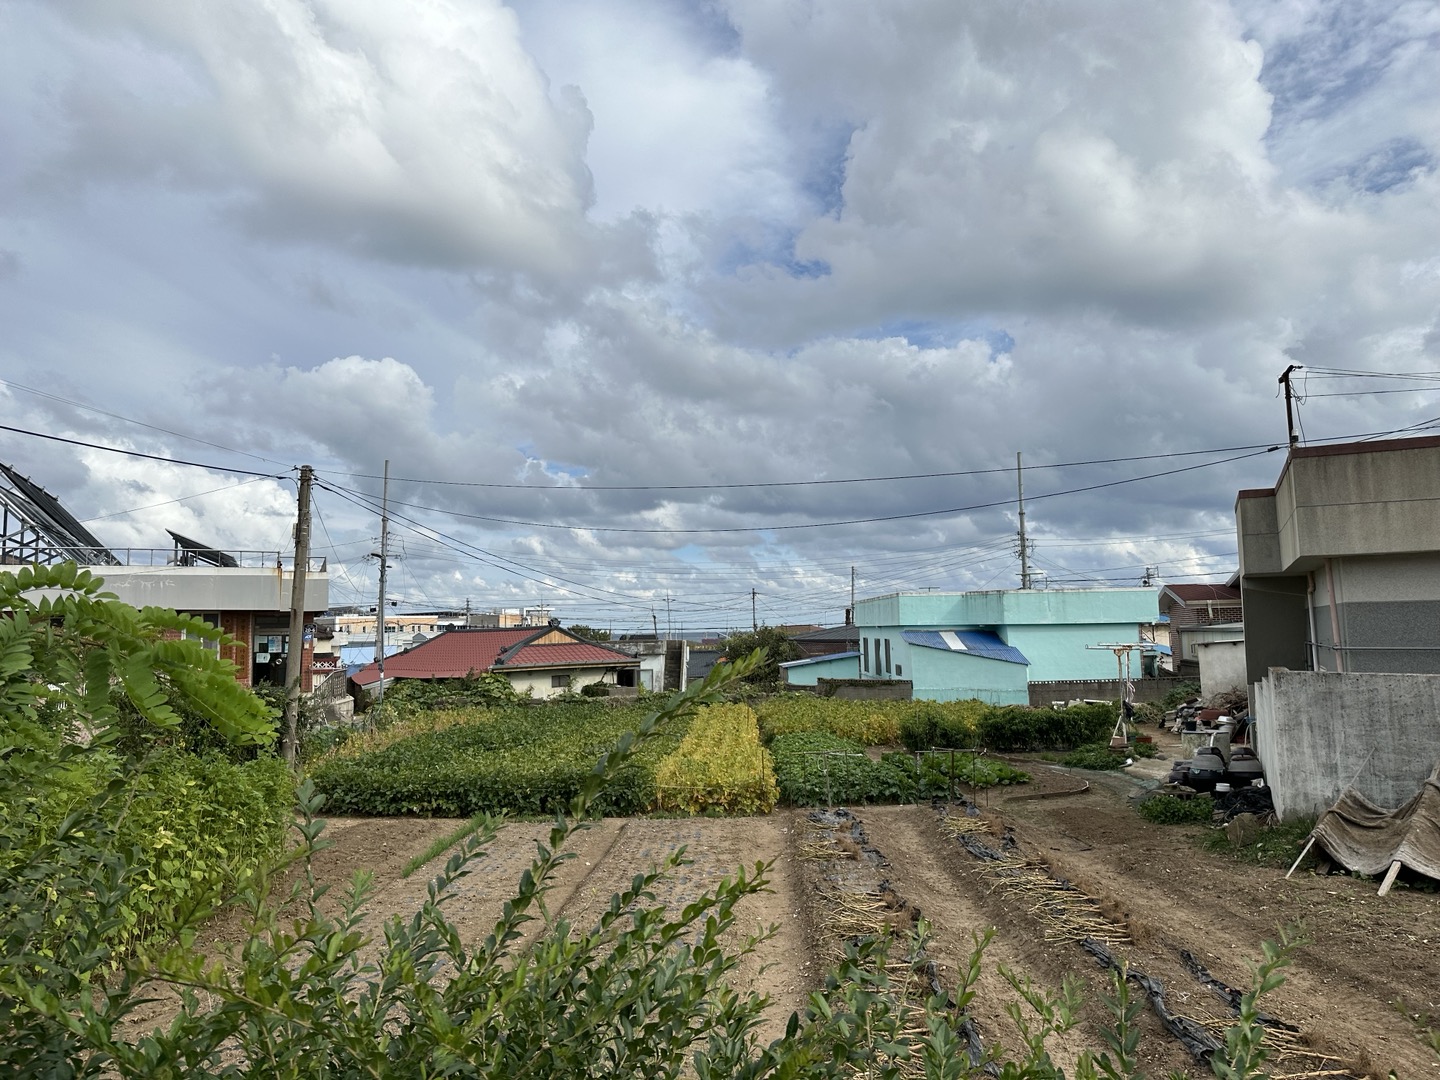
<box><xmin>310</xmin><ymin>691</ymin><xmax>1113</xmax><ymax>818</ymax></box>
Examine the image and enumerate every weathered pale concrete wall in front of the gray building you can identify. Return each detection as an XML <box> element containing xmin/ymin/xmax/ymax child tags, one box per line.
<box><xmin>1250</xmin><ymin>668</ymin><xmax>1440</xmax><ymax>819</ymax></box>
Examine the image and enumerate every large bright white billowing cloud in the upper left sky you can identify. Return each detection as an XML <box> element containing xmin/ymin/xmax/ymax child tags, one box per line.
<box><xmin>37</xmin><ymin>0</ymin><xmax>595</xmax><ymax>275</ymax></box>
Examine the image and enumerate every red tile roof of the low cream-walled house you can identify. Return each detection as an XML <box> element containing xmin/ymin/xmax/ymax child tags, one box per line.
<box><xmin>354</xmin><ymin>626</ymin><xmax>639</xmax><ymax>685</ymax></box>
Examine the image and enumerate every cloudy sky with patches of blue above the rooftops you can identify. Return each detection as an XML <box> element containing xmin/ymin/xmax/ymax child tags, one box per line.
<box><xmin>0</xmin><ymin>0</ymin><xmax>1440</xmax><ymax>632</ymax></box>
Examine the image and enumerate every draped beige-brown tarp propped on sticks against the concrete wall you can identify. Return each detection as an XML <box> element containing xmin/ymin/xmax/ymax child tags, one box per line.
<box><xmin>1310</xmin><ymin>765</ymin><xmax>1440</xmax><ymax>878</ymax></box>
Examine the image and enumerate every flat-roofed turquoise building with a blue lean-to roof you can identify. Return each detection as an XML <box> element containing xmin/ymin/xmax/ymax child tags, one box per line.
<box><xmin>855</xmin><ymin>589</ymin><xmax>1159</xmax><ymax>704</ymax></box>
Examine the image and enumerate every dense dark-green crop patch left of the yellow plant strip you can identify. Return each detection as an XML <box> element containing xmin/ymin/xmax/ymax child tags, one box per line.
<box><xmin>311</xmin><ymin>700</ymin><xmax>685</xmax><ymax>818</ymax></box>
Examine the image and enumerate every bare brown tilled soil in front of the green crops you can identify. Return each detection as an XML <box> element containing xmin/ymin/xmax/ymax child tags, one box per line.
<box><xmin>185</xmin><ymin>762</ymin><xmax>1440</xmax><ymax>1080</ymax></box>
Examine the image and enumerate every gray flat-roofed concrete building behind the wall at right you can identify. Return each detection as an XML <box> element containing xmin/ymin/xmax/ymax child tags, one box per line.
<box><xmin>1236</xmin><ymin>436</ymin><xmax>1440</xmax><ymax>683</ymax></box>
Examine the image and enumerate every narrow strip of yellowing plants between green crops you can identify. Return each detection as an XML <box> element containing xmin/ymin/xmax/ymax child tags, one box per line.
<box><xmin>655</xmin><ymin>704</ymin><xmax>779</xmax><ymax>814</ymax></box>
